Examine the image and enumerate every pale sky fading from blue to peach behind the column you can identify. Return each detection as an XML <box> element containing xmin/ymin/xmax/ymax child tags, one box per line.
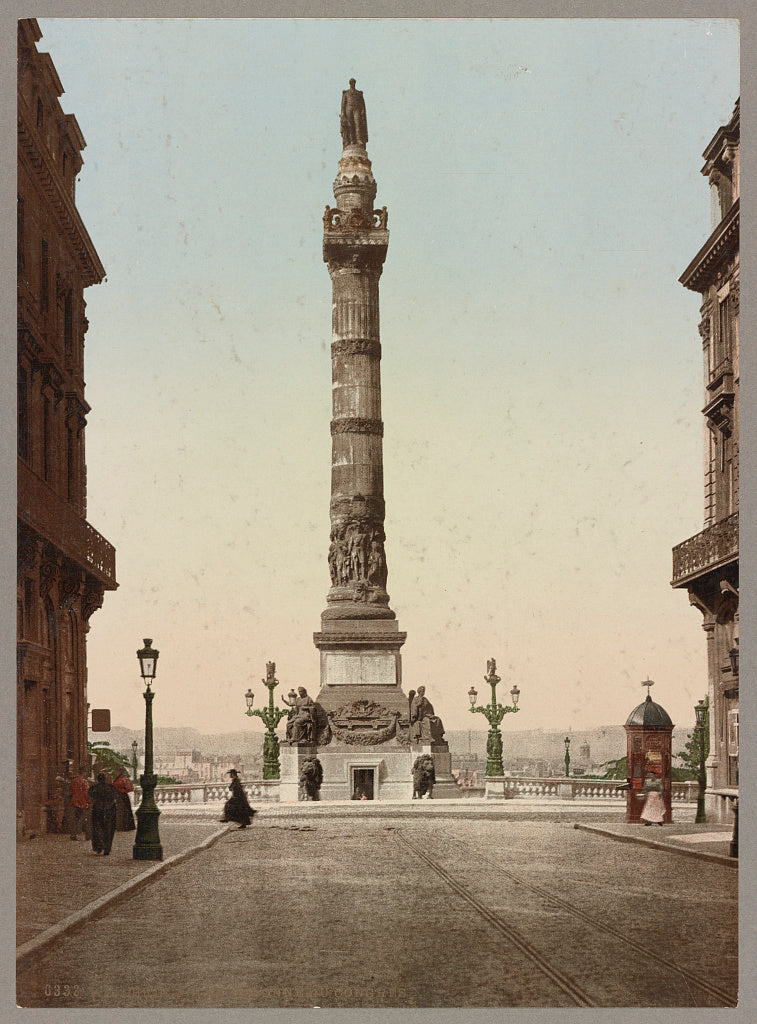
<box><xmin>38</xmin><ymin>18</ymin><xmax>739</xmax><ymax>734</ymax></box>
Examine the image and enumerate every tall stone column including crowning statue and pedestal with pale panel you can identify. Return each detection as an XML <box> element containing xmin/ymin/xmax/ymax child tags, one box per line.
<box><xmin>313</xmin><ymin>82</ymin><xmax>407</xmax><ymax>712</ymax></box>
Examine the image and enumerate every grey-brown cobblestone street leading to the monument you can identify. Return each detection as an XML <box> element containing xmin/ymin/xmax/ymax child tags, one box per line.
<box><xmin>17</xmin><ymin>814</ymin><xmax>738</xmax><ymax>1008</ymax></box>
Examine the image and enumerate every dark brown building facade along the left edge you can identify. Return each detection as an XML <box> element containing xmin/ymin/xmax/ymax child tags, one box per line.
<box><xmin>16</xmin><ymin>18</ymin><xmax>117</xmax><ymax>833</ymax></box>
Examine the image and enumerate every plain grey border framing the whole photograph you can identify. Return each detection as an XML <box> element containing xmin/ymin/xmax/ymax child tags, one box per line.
<box><xmin>0</xmin><ymin>0</ymin><xmax>757</xmax><ymax>1024</ymax></box>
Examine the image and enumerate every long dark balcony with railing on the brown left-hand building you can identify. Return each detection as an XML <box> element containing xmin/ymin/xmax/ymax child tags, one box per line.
<box><xmin>18</xmin><ymin>459</ymin><xmax>118</xmax><ymax>590</ymax></box>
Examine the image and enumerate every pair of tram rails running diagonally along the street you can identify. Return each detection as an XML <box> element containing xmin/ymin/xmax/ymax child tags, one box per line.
<box><xmin>391</xmin><ymin>828</ymin><xmax>737</xmax><ymax>1008</ymax></box>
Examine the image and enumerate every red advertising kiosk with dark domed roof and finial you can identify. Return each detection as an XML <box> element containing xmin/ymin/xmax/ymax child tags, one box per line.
<box><xmin>624</xmin><ymin>679</ymin><xmax>673</xmax><ymax>824</ymax></box>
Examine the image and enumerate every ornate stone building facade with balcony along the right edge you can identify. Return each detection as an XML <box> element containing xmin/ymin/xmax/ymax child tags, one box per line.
<box><xmin>672</xmin><ymin>102</ymin><xmax>740</xmax><ymax>820</ymax></box>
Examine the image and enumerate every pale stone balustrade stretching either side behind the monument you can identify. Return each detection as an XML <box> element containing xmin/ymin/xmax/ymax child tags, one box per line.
<box><xmin>134</xmin><ymin>776</ymin><xmax>699</xmax><ymax>806</ymax></box>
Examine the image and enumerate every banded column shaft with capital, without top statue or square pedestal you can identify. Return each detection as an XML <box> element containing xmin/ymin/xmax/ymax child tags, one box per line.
<box><xmin>324</xmin><ymin>137</ymin><xmax>394</xmax><ymax>618</ymax></box>
